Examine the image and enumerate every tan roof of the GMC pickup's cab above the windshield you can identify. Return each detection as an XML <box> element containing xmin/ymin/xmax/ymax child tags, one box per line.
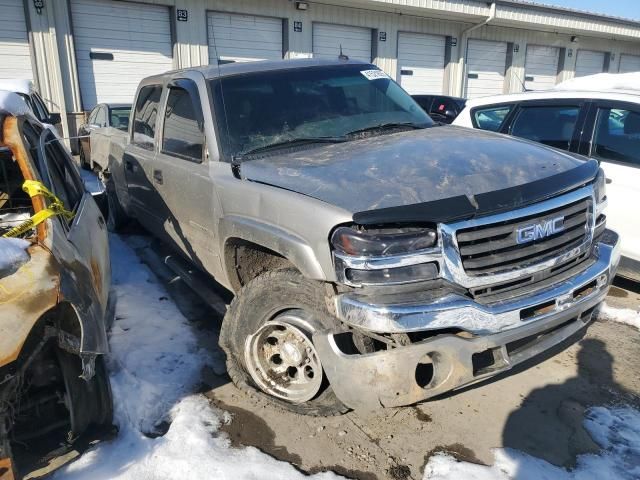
<box><xmin>142</xmin><ymin>55</ymin><xmax>371</xmax><ymax>83</ymax></box>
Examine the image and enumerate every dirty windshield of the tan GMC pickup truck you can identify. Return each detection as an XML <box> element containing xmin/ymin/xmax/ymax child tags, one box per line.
<box><xmin>211</xmin><ymin>65</ymin><xmax>433</xmax><ymax>159</ymax></box>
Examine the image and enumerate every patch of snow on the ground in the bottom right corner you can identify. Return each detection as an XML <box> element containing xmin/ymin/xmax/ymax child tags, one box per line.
<box><xmin>424</xmin><ymin>407</ymin><xmax>640</xmax><ymax>480</ymax></box>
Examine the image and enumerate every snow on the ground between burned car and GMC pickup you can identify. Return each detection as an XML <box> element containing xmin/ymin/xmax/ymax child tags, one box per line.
<box><xmin>55</xmin><ymin>235</ymin><xmax>338</xmax><ymax>480</ymax></box>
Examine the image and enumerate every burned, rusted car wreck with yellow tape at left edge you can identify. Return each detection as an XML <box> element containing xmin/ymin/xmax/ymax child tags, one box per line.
<box><xmin>0</xmin><ymin>91</ymin><xmax>114</xmax><ymax>480</ymax></box>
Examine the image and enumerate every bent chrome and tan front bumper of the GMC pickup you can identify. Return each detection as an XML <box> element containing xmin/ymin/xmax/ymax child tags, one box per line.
<box><xmin>314</xmin><ymin>230</ymin><xmax>620</xmax><ymax>409</ymax></box>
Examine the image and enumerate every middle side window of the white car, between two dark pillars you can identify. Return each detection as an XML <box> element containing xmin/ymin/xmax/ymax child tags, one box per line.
<box><xmin>509</xmin><ymin>105</ymin><xmax>580</xmax><ymax>150</ymax></box>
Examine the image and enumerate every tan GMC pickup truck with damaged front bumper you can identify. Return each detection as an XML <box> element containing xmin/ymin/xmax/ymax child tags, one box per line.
<box><xmin>106</xmin><ymin>60</ymin><xmax>619</xmax><ymax>415</ymax></box>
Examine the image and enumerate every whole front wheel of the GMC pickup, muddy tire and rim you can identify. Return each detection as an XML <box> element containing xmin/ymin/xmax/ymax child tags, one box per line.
<box><xmin>220</xmin><ymin>270</ymin><xmax>348</xmax><ymax>416</ymax></box>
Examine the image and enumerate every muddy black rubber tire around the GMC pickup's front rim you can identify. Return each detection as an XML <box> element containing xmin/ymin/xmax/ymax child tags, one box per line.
<box><xmin>220</xmin><ymin>269</ymin><xmax>349</xmax><ymax>417</ymax></box>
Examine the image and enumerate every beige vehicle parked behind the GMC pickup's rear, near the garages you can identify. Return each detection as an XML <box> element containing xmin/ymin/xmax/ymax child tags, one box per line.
<box><xmin>78</xmin><ymin>103</ymin><xmax>131</xmax><ymax>170</ymax></box>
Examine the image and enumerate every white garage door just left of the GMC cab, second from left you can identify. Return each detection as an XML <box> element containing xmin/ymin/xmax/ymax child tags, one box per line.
<box><xmin>71</xmin><ymin>0</ymin><xmax>173</xmax><ymax>110</ymax></box>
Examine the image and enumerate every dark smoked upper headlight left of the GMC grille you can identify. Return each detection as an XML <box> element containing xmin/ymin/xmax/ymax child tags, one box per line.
<box><xmin>331</xmin><ymin>227</ymin><xmax>436</xmax><ymax>257</ymax></box>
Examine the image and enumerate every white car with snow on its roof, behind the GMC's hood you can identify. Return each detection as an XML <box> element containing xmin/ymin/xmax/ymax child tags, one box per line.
<box><xmin>453</xmin><ymin>73</ymin><xmax>640</xmax><ymax>280</ymax></box>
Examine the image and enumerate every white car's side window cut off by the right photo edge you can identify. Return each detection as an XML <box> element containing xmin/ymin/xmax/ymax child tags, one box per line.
<box><xmin>592</xmin><ymin>108</ymin><xmax>640</xmax><ymax>166</ymax></box>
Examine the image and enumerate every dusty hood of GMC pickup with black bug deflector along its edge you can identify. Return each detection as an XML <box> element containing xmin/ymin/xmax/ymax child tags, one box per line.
<box><xmin>240</xmin><ymin>126</ymin><xmax>598</xmax><ymax>224</ymax></box>
